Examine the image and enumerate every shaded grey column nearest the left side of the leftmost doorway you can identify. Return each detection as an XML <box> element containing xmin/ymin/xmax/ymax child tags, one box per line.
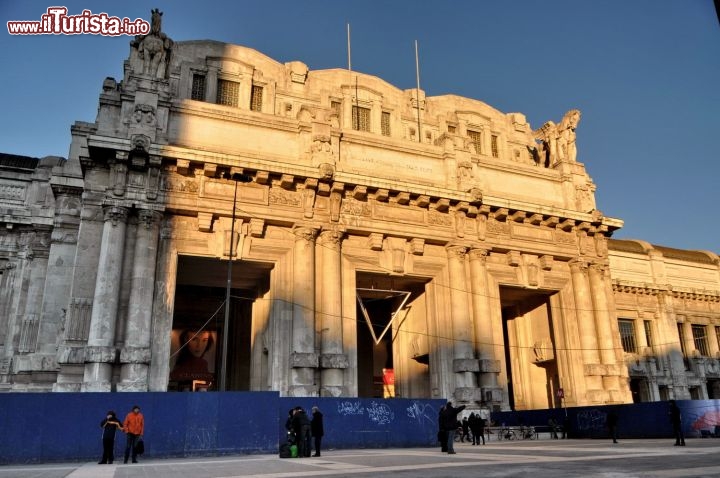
<box><xmin>118</xmin><ymin>209</ymin><xmax>162</xmax><ymax>392</ymax></box>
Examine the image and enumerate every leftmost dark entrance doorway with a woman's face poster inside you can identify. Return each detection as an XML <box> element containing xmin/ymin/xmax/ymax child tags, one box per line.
<box><xmin>168</xmin><ymin>256</ymin><xmax>271</xmax><ymax>391</ymax></box>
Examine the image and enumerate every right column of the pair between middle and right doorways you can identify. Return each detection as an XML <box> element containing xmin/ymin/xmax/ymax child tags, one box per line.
<box><xmin>469</xmin><ymin>249</ymin><xmax>500</xmax><ymax>390</ymax></box>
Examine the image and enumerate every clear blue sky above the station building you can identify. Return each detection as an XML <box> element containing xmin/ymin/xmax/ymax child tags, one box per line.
<box><xmin>0</xmin><ymin>0</ymin><xmax>720</xmax><ymax>253</ymax></box>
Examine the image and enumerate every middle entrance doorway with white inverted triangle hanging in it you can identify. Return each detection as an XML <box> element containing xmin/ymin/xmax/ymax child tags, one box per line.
<box><xmin>355</xmin><ymin>273</ymin><xmax>430</xmax><ymax>398</ymax></box>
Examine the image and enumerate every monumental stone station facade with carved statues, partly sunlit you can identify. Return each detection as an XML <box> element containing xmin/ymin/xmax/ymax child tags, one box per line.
<box><xmin>0</xmin><ymin>13</ymin><xmax>720</xmax><ymax>410</ymax></box>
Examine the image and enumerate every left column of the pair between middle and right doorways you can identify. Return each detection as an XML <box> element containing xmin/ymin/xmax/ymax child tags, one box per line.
<box><xmin>447</xmin><ymin>246</ymin><xmax>480</xmax><ymax>402</ymax></box>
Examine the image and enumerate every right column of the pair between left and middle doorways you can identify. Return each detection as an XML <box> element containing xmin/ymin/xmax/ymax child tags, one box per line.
<box><xmin>316</xmin><ymin>231</ymin><xmax>348</xmax><ymax>397</ymax></box>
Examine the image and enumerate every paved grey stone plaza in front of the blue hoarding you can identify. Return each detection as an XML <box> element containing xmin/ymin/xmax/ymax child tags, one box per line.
<box><xmin>0</xmin><ymin>439</ymin><xmax>720</xmax><ymax>478</ymax></box>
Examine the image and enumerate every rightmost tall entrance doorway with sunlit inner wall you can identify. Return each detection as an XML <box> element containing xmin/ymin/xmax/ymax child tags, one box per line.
<box><xmin>500</xmin><ymin>287</ymin><xmax>562</xmax><ymax>410</ymax></box>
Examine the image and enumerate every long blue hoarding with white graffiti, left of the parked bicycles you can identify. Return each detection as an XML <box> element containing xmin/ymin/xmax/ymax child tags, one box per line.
<box><xmin>0</xmin><ymin>392</ymin><xmax>445</xmax><ymax>464</ymax></box>
